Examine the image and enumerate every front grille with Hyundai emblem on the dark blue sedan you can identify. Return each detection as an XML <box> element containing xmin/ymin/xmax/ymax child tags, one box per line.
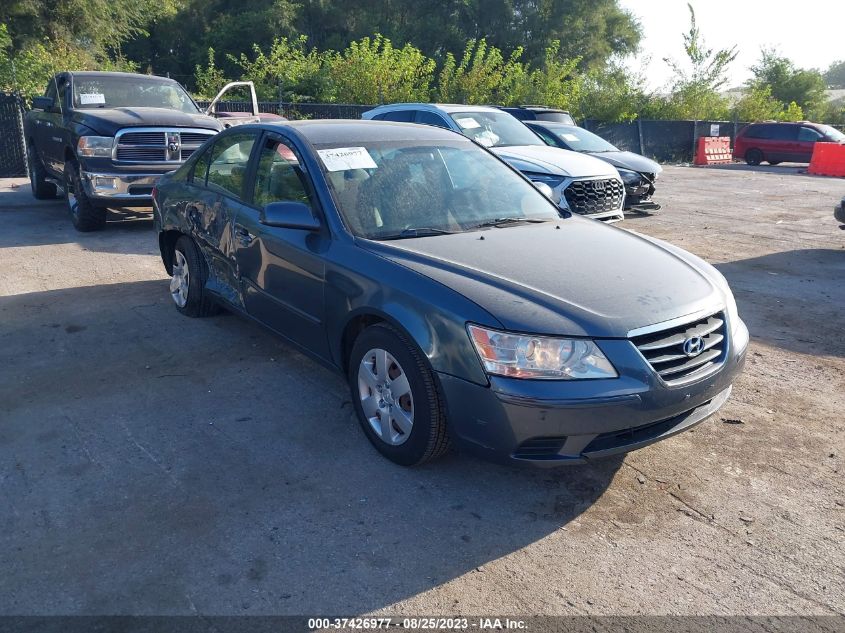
<box><xmin>631</xmin><ymin>313</ymin><xmax>727</xmax><ymax>382</ymax></box>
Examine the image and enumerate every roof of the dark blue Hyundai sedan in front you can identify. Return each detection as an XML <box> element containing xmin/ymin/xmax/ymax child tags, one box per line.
<box><xmin>258</xmin><ymin>119</ymin><xmax>471</xmax><ymax>145</ymax></box>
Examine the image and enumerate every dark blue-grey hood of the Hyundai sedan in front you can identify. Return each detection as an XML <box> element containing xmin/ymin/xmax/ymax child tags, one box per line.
<box><xmin>365</xmin><ymin>217</ymin><xmax>726</xmax><ymax>338</ymax></box>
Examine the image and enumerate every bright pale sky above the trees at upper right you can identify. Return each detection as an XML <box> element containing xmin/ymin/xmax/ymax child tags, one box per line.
<box><xmin>620</xmin><ymin>0</ymin><xmax>845</xmax><ymax>89</ymax></box>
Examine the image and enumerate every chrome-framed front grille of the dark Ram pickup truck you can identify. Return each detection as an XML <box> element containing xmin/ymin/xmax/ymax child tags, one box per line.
<box><xmin>114</xmin><ymin>128</ymin><xmax>217</xmax><ymax>163</ymax></box>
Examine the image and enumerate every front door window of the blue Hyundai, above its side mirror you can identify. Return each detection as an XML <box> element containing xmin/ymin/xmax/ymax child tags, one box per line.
<box><xmin>253</xmin><ymin>138</ymin><xmax>311</xmax><ymax>208</ymax></box>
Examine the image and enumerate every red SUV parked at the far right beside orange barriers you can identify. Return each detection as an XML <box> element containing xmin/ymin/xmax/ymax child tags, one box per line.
<box><xmin>734</xmin><ymin>121</ymin><xmax>845</xmax><ymax>165</ymax></box>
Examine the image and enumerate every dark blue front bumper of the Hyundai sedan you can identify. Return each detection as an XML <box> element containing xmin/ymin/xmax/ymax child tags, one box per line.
<box><xmin>439</xmin><ymin>321</ymin><xmax>748</xmax><ymax>467</ymax></box>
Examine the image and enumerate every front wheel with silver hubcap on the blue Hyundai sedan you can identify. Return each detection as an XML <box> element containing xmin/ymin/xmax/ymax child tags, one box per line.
<box><xmin>348</xmin><ymin>323</ymin><xmax>449</xmax><ymax>466</ymax></box>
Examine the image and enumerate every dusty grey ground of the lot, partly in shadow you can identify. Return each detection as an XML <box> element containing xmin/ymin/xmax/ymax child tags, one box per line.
<box><xmin>0</xmin><ymin>167</ymin><xmax>845</xmax><ymax>615</ymax></box>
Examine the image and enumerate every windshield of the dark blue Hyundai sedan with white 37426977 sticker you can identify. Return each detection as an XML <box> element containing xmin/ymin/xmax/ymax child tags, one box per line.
<box><xmin>316</xmin><ymin>139</ymin><xmax>561</xmax><ymax>240</ymax></box>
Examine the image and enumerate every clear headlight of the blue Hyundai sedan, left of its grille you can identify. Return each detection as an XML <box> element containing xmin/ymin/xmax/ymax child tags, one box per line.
<box><xmin>467</xmin><ymin>325</ymin><xmax>619</xmax><ymax>380</ymax></box>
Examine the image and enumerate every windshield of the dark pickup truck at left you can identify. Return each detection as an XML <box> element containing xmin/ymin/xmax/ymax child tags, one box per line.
<box><xmin>73</xmin><ymin>76</ymin><xmax>199</xmax><ymax>114</ymax></box>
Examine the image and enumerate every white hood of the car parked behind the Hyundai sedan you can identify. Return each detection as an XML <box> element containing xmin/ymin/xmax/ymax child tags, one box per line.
<box><xmin>491</xmin><ymin>145</ymin><xmax>619</xmax><ymax>178</ymax></box>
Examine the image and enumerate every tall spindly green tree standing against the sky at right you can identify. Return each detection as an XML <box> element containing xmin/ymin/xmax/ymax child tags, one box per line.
<box><xmin>662</xmin><ymin>4</ymin><xmax>738</xmax><ymax>119</ymax></box>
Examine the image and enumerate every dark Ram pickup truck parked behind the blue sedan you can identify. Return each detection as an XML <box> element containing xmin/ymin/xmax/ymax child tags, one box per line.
<box><xmin>24</xmin><ymin>72</ymin><xmax>228</xmax><ymax>231</ymax></box>
